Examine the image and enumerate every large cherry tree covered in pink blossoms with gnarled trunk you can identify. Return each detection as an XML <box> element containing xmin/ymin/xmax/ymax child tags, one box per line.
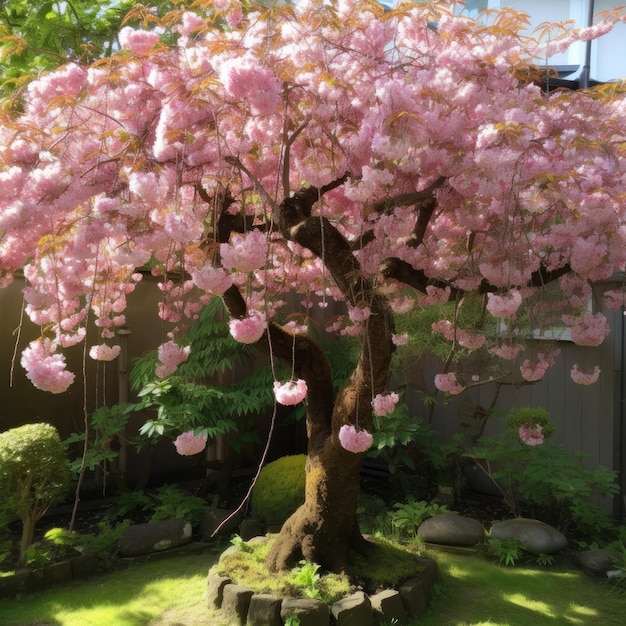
<box><xmin>0</xmin><ymin>0</ymin><xmax>626</xmax><ymax>571</ymax></box>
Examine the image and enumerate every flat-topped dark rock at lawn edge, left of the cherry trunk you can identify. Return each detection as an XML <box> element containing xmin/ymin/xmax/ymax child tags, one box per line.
<box><xmin>119</xmin><ymin>519</ymin><xmax>191</xmax><ymax>557</ymax></box>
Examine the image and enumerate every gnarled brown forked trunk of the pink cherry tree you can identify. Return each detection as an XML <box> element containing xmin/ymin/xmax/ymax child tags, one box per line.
<box><xmin>224</xmin><ymin>180</ymin><xmax>393</xmax><ymax>572</ymax></box>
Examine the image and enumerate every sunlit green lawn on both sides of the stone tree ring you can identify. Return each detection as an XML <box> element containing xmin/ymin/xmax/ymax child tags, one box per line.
<box><xmin>0</xmin><ymin>540</ymin><xmax>626</xmax><ymax>626</ymax></box>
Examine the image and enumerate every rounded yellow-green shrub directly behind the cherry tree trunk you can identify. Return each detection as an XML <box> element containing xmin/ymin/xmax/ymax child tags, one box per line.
<box><xmin>250</xmin><ymin>454</ymin><xmax>306</xmax><ymax>526</ymax></box>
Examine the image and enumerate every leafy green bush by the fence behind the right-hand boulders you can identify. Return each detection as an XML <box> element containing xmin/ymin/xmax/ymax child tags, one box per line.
<box><xmin>469</xmin><ymin>437</ymin><xmax>618</xmax><ymax>543</ymax></box>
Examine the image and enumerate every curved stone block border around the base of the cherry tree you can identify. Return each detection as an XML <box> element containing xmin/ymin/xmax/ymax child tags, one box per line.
<box><xmin>207</xmin><ymin>557</ymin><xmax>438</xmax><ymax>626</ymax></box>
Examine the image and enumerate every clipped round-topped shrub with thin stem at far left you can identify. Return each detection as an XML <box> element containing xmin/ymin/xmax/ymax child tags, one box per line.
<box><xmin>0</xmin><ymin>424</ymin><xmax>70</xmax><ymax>564</ymax></box>
